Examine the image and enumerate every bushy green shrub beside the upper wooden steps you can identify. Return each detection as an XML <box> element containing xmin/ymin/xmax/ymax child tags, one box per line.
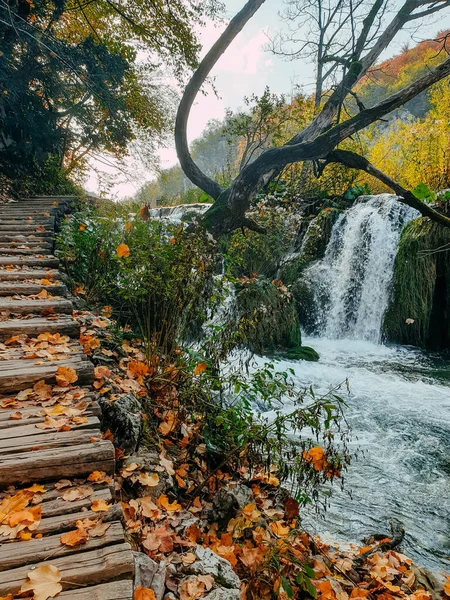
<box><xmin>58</xmin><ymin>206</ymin><xmax>220</xmax><ymax>356</ymax></box>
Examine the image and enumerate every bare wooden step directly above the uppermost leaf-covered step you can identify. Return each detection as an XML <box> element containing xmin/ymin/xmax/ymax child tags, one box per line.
<box><xmin>0</xmin><ymin>315</ymin><xmax>80</xmax><ymax>340</ymax></box>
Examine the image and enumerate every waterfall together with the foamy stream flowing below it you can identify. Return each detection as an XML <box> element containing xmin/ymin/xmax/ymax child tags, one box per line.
<box><xmin>270</xmin><ymin>194</ymin><xmax>450</xmax><ymax>571</ymax></box>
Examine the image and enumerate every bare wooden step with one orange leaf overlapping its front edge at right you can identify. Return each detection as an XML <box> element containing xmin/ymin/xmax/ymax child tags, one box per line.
<box><xmin>0</xmin><ymin>358</ymin><xmax>94</xmax><ymax>394</ymax></box>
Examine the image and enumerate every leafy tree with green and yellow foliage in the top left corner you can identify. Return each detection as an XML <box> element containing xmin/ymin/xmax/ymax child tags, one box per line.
<box><xmin>0</xmin><ymin>0</ymin><xmax>220</xmax><ymax>192</ymax></box>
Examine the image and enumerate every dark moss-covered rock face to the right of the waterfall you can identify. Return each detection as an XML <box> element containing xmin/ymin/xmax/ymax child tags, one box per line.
<box><xmin>384</xmin><ymin>217</ymin><xmax>450</xmax><ymax>348</ymax></box>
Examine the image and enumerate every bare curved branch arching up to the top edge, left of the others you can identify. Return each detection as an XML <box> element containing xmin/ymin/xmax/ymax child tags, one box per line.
<box><xmin>175</xmin><ymin>0</ymin><xmax>265</xmax><ymax>200</ymax></box>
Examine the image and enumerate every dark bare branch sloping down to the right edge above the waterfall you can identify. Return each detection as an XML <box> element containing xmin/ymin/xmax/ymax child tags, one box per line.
<box><xmin>325</xmin><ymin>150</ymin><xmax>450</xmax><ymax>227</ymax></box>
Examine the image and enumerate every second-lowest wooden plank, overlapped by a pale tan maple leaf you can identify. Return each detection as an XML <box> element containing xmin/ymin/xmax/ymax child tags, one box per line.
<box><xmin>0</xmin><ymin>544</ymin><xmax>134</xmax><ymax>596</ymax></box>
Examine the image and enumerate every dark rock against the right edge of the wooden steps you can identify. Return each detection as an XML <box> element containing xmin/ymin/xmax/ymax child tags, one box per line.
<box><xmin>98</xmin><ymin>394</ymin><xmax>142</xmax><ymax>453</ymax></box>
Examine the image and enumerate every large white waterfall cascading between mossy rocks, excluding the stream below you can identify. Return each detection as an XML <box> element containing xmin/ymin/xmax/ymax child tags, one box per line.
<box><xmin>306</xmin><ymin>194</ymin><xmax>419</xmax><ymax>343</ymax></box>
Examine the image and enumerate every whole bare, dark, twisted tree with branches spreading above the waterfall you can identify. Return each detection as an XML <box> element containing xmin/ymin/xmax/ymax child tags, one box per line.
<box><xmin>175</xmin><ymin>0</ymin><xmax>450</xmax><ymax>235</ymax></box>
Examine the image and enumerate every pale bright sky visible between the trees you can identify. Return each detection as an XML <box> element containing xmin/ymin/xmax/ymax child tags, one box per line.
<box><xmin>85</xmin><ymin>0</ymin><xmax>450</xmax><ymax>199</ymax></box>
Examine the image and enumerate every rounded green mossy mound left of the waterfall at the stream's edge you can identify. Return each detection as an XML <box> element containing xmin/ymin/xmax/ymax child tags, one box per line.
<box><xmin>236</xmin><ymin>279</ymin><xmax>301</xmax><ymax>354</ymax></box>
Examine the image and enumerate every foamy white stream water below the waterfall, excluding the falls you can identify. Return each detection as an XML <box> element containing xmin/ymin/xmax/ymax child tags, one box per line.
<box><xmin>268</xmin><ymin>338</ymin><xmax>450</xmax><ymax>572</ymax></box>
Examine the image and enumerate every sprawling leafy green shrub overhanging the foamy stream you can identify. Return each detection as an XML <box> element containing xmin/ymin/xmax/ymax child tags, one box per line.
<box><xmin>183</xmin><ymin>356</ymin><xmax>349</xmax><ymax>506</ymax></box>
